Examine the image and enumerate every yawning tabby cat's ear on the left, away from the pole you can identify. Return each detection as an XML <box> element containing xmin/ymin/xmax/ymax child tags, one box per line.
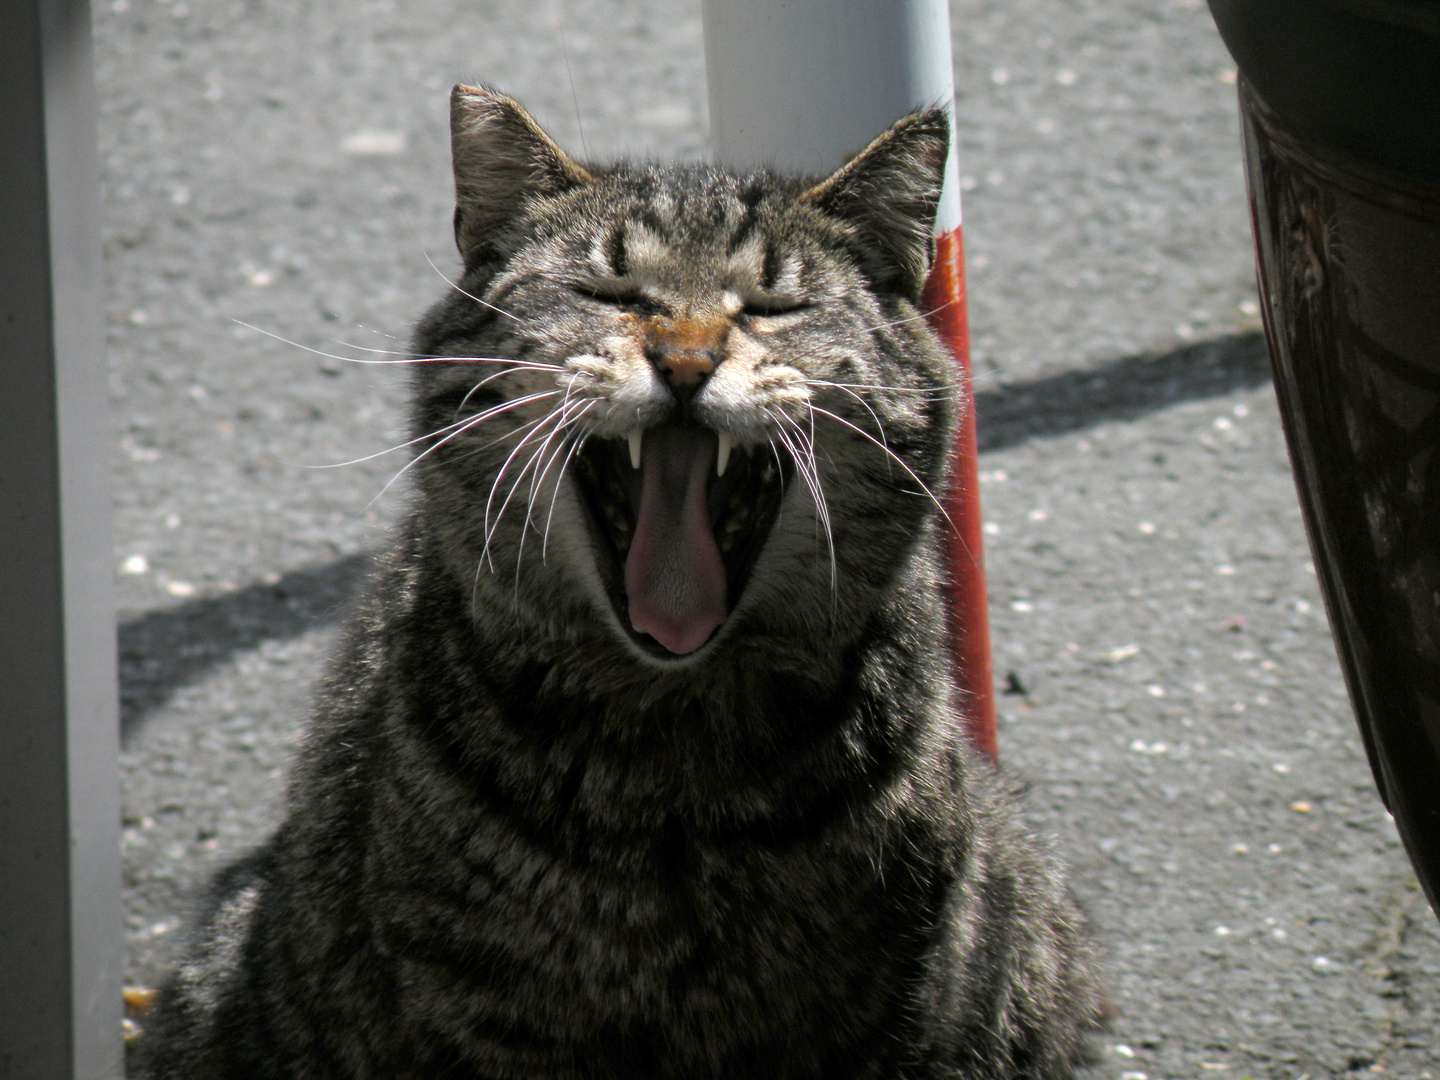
<box><xmin>451</xmin><ymin>85</ymin><xmax>593</xmax><ymax>269</ymax></box>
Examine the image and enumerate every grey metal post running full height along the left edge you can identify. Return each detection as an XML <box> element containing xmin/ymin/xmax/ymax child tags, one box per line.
<box><xmin>0</xmin><ymin>0</ymin><xmax>124</xmax><ymax>1080</ymax></box>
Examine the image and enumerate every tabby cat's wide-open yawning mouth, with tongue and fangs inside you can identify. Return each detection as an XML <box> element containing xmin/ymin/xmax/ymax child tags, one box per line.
<box><xmin>573</xmin><ymin>425</ymin><xmax>793</xmax><ymax>657</ymax></box>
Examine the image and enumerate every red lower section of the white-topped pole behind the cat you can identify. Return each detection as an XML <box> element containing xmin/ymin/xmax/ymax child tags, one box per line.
<box><xmin>922</xmin><ymin>228</ymin><xmax>999</xmax><ymax>759</ymax></box>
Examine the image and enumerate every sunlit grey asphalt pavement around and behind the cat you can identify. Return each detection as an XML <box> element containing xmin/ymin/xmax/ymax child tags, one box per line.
<box><xmin>95</xmin><ymin>0</ymin><xmax>1440</xmax><ymax>1080</ymax></box>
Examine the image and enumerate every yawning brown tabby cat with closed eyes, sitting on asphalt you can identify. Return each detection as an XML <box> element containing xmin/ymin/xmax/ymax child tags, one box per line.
<box><xmin>143</xmin><ymin>86</ymin><xmax>1100</xmax><ymax>1080</ymax></box>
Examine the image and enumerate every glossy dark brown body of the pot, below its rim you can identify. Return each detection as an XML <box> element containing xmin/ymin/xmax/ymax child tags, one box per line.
<box><xmin>1240</xmin><ymin>80</ymin><xmax>1440</xmax><ymax>912</ymax></box>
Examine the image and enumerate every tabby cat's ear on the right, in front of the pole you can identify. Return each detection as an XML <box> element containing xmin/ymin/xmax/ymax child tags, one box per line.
<box><xmin>801</xmin><ymin>109</ymin><xmax>950</xmax><ymax>301</ymax></box>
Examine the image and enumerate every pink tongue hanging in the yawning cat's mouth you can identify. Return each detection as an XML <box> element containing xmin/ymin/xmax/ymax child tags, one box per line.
<box><xmin>625</xmin><ymin>428</ymin><xmax>726</xmax><ymax>655</ymax></box>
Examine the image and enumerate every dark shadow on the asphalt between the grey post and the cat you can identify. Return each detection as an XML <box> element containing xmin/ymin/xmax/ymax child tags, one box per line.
<box><xmin>120</xmin><ymin>552</ymin><xmax>370</xmax><ymax>743</ymax></box>
